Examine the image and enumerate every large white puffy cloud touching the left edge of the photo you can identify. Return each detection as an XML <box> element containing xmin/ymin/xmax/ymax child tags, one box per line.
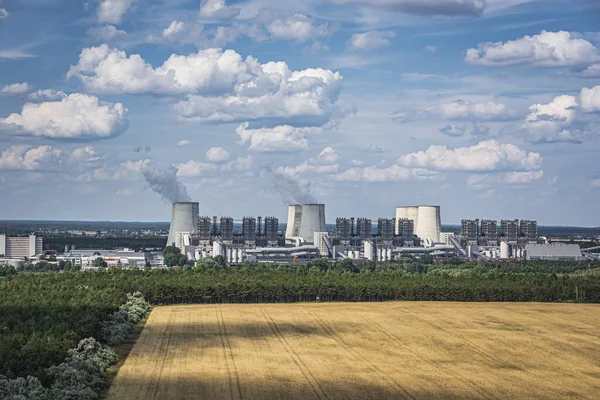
<box><xmin>0</xmin><ymin>93</ymin><xmax>127</xmax><ymax>139</ymax></box>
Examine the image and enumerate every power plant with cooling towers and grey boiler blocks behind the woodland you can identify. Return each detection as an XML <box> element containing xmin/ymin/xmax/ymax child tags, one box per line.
<box><xmin>167</xmin><ymin>202</ymin><xmax>562</xmax><ymax>264</ymax></box>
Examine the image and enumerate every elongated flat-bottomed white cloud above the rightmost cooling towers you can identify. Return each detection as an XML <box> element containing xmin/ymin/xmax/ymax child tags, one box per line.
<box><xmin>398</xmin><ymin>140</ymin><xmax>542</xmax><ymax>172</ymax></box>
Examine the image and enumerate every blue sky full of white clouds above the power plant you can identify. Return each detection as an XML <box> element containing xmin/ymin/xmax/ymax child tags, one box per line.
<box><xmin>0</xmin><ymin>0</ymin><xmax>600</xmax><ymax>226</ymax></box>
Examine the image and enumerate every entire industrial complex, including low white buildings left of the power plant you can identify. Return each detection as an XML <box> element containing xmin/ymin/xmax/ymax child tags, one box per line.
<box><xmin>0</xmin><ymin>202</ymin><xmax>598</xmax><ymax>269</ymax></box>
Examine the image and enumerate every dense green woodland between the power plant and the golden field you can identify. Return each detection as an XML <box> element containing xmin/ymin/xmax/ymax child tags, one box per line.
<box><xmin>0</xmin><ymin>259</ymin><xmax>600</xmax><ymax>394</ymax></box>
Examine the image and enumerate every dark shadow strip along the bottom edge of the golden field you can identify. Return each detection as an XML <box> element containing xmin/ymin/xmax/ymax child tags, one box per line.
<box><xmin>107</xmin><ymin>371</ymin><xmax>481</xmax><ymax>400</ymax></box>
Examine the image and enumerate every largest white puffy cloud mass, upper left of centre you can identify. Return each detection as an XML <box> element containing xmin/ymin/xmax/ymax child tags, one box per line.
<box><xmin>67</xmin><ymin>45</ymin><xmax>342</xmax><ymax>124</ymax></box>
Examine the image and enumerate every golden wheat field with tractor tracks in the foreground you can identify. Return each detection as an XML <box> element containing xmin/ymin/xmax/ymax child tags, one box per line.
<box><xmin>108</xmin><ymin>302</ymin><xmax>600</xmax><ymax>400</ymax></box>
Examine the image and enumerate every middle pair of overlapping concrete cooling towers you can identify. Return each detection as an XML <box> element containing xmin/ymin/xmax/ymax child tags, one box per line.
<box><xmin>285</xmin><ymin>204</ymin><xmax>327</xmax><ymax>242</ymax></box>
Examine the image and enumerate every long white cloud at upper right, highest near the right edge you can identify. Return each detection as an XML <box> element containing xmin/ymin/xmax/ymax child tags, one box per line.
<box><xmin>465</xmin><ymin>31</ymin><xmax>600</xmax><ymax>67</ymax></box>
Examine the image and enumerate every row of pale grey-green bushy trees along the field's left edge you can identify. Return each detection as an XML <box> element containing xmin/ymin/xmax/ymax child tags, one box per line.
<box><xmin>0</xmin><ymin>292</ymin><xmax>150</xmax><ymax>400</ymax></box>
